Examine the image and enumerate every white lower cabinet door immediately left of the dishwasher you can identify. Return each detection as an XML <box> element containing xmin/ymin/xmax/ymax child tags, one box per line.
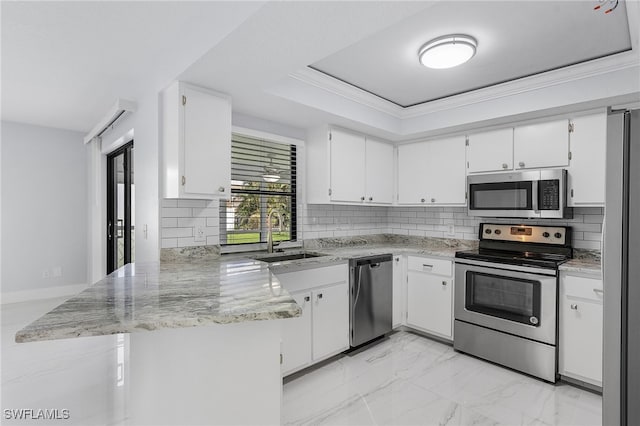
<box><xmin>311</xmin><ymin>282</ymin><xmax>349</xmax><ymax>360</ymax></box>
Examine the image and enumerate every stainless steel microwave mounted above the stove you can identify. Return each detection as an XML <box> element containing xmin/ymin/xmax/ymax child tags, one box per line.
<box><xmin>467</xmin><ymin>169</ymin><xmax>573</xmax><ymax>219</ymax></box>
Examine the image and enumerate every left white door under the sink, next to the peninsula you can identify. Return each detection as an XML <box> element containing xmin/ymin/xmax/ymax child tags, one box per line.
<box><xmin>281</xmin><ymin>291</ymin><xmax>311</xmax><ymax>375</ymax></box>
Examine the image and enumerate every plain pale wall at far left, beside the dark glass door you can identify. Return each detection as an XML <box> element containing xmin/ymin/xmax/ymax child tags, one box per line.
<box><xmin>1</xmin><ymin>122</ymin><xmax>87</xmax><ymax>303</ymax></box>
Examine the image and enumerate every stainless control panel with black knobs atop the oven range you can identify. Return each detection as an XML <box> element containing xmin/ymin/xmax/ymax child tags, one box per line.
<box><xmin>480</xmin><ymin>223</ymin><xmax>570</xmax><ymax>245</ymax></box>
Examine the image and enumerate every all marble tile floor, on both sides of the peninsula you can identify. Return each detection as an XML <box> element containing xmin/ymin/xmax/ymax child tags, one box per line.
<box><xmin>0</xmin><ymin>298</ymin><xmax>602</xmax><ymax>426</ymax></box>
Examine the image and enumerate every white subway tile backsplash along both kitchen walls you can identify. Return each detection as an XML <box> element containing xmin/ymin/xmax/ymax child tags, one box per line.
<box><xmin>162</xmin><ymin>199</ymin><xmax>604</xmax><ymax>250</ymax></box>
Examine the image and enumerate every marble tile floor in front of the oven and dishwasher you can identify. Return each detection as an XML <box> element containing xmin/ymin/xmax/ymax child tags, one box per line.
<box><xmin>283</xmin><ymin>332</ymin><xmax>602</xmax><ymax>426</ymax></box>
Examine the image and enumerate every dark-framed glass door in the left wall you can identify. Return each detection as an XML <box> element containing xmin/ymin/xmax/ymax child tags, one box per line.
<box><xmin>107</xmin><ymin>141</ymin><xmax>135</xmax><ymax>274</ymax></box>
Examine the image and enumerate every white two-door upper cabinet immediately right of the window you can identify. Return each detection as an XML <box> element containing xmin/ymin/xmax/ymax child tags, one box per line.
<box><xmin>306</xmin><ymin>127</ymin><xmax>393</xmax><ymax>204</ymax></box>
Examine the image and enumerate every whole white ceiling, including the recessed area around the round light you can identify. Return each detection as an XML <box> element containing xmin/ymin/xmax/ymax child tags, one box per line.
<box><xmin>1</xmin><ymin>0</ymin><xmax>638</xmax><ymax>139</ymax></box>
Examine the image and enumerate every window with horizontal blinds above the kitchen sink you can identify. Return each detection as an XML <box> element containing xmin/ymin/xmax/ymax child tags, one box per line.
<box><xmin>220</xmin><ymin>134</ymin><xmax>296</xmax><ymax>245</ymax></box>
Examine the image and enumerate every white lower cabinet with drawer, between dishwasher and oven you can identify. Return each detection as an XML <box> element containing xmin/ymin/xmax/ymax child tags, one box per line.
<box><xmin>407</xmin><ymin>256</ymin><xmax>453</xmax><ymax>340</ymax></box>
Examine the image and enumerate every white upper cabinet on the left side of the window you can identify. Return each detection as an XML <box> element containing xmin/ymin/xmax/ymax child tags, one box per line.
<box><xmin>161</xmin><ymin>82</ymin><xmax>231</xmax><ymax>200</ymax></box>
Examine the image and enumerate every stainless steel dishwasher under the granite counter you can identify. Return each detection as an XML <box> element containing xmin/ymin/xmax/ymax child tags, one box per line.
<box><xmin>349</xmin><ymin>254</ymin><xmax>393</xmax><ymax>347</ymax></box>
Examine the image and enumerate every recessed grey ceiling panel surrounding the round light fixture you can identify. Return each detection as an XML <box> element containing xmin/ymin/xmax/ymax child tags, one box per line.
<box><xmin>310</xmin><ymin>1</ymin><xmax>631</xmax><ymax>107</ymax></box>
